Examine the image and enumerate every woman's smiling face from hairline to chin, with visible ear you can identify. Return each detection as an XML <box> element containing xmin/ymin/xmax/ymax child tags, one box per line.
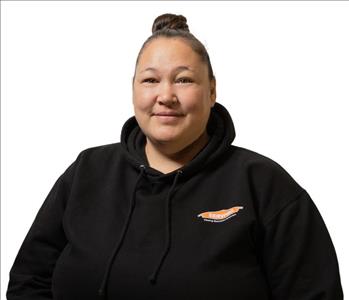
<box><xmin>133</xmin><ymin>37</ymin><xmax>216</xmax><ymax>149</ymax></box>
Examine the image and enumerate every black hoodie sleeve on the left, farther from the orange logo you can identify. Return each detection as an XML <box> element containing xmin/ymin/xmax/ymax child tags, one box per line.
<box><xmin>6</xmin><ymin>154</ymin><xmax>80</xmax><ymax>300</ymax></box>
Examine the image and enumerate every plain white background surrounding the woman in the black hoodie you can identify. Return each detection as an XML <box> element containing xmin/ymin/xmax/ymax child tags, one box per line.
<box><xmin>1</xmin><ymin>1</ymin><xmax>349</xmax><ymax>299</ymax></box>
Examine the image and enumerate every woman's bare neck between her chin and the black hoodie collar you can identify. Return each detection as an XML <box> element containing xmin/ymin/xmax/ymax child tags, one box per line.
<box><xmin>145</xmin><ymin>130</ymin><xmax>209</xmax><ymax>174</ymax></box>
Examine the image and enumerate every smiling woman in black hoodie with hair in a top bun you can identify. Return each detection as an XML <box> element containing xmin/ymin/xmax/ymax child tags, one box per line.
<box><xmin>7</xmin><ymin>14</ymin><xmax>343</xmax><ymax>300</ymax></box>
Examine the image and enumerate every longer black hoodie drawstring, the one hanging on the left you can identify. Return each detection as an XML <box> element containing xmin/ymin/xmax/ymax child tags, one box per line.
<box><xmin>98</xmin><ymin>165</ymin><xmax>145</xmax><ymax>297</ymax></box>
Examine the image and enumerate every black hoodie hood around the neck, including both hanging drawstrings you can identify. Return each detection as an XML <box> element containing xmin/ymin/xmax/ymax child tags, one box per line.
<box><xmin>99</xmin><ymin>102</ymin><xmax>235</xmax><ymax>296</ymax></box>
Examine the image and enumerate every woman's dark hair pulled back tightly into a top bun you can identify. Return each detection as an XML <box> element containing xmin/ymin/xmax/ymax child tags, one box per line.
<box><xmin>136</xmin><ymin>14</ymin><xmax>215</xmax><ymax>80</ymax></box>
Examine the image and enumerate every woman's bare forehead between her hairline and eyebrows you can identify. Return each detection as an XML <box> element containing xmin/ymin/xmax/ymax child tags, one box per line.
<box><xmin>137</xmin><ymin>37</ymin><xmax>205</xmax><ymax>71</ymax></box>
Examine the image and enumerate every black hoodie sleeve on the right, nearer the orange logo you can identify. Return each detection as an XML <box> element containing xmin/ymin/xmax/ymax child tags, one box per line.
<box><xmin>262</xmin><ymin>190</ymin><xmax>343</xmax><ymax>300</ymax></box>
